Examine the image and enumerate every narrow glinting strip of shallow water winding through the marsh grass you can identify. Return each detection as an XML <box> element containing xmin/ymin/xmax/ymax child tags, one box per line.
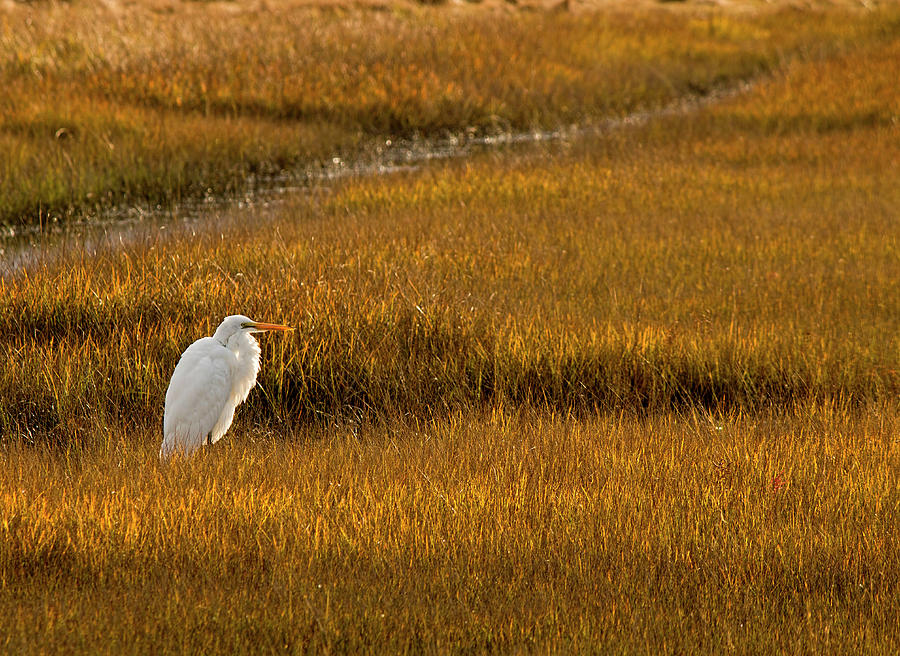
<box><xmin>0</xmin><ymin>82</ymin><xmax>753</xmax><ymax>275</ymax></box>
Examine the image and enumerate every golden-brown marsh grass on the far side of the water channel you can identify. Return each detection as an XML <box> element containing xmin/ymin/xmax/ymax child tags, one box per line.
<box><xmin>0</xmin><ymin>2</ymin><xmax>895</xmax><ymax>224</ymax></box>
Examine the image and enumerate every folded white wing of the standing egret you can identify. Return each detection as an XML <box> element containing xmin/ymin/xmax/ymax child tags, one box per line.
<box><xmin>160</xmin><ymin>337</ymin><xmax>235</xmax><ymax>457</ymax></box>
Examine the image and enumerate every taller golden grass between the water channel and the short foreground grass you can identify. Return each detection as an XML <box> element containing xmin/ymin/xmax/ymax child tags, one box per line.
<box><xmin>0</xmin><ymin>32</ymin><xmax>900</xmax><ymax>441</ymax></box>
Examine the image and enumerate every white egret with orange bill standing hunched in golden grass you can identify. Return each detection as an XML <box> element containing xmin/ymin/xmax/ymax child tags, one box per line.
<box><xmin>159</xmin><ymin>314</ymin><xmax>293</xmax><ymax>460</ymax></box>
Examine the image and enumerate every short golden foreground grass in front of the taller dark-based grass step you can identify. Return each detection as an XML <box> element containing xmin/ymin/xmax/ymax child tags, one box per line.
<box><xmin>0</xmin><ymin>406</ymin><xmax>900</xmax><ymax>654</ymax></box>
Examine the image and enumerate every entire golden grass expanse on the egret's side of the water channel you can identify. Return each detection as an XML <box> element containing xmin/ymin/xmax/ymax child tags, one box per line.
<box><xmin>0</xmin><ymin>3</ymin><xmax>900</xmax><ymax>655</ymax></box>
